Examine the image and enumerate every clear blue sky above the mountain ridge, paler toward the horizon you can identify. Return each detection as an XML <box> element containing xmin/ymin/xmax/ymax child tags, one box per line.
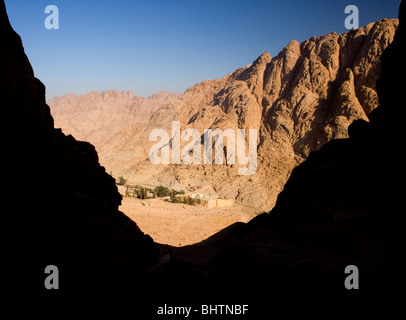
<box><xmin>5</xmin><ymin>0</ymin><xmax>400</xmax><ymax>99</ymax></box>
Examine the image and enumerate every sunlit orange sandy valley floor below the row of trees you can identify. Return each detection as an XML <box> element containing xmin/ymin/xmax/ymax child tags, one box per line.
<box><xmin>120</xmin><ymin>197</ymin><xmax>257</xmax><ymax>247</ymax></box>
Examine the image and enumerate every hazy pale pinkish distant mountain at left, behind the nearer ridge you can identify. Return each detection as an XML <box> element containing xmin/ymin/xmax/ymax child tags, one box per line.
<box><xmin>51</xmin><ymin>90</ymin><xmax>178</xmax><ymax>154</ymax></box>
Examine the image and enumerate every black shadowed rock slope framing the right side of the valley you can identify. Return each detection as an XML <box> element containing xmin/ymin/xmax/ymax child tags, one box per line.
<box><xmin>145</xmin><ymin>1</ymin><xmax>406</xmax><ymax>311</ymax></box>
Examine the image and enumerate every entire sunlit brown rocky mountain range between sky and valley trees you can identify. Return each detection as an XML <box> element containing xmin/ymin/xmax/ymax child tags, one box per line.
<box><xmin>48</xmin><ymin>19</ymin><xmax>398</xmax><ymax>210</ymax></box>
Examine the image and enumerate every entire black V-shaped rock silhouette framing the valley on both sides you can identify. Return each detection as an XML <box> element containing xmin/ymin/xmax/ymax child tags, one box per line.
<box><xmin>0</xmin><ymin>1</ymin><xmax>406</xmax><ymax>312</ymax></box>
